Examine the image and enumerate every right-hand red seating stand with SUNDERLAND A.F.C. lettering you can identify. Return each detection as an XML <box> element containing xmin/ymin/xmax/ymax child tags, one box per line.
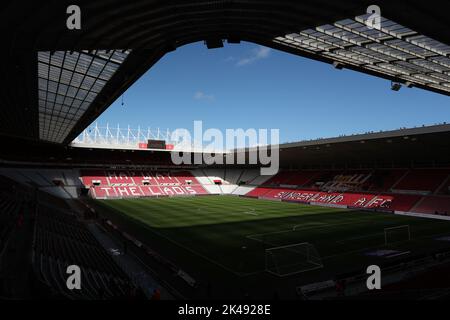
<box><xmin>234</xmin><ymin>169</ymin><xmax>450</xmax><ymax>214</ymax></box>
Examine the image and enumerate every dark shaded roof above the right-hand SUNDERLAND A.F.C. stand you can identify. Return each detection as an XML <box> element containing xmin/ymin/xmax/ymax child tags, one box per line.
<box><xmin>280</xmin><ymin>124</ymin><xmax>450</xmax><ymax>168</ymax></box>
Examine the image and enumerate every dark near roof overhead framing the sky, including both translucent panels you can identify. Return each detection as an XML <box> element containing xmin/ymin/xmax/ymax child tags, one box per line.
<box><xmin>0</xmin><ymin>0</ymin><xmax>450</xmax><ymax>144</ymax></box>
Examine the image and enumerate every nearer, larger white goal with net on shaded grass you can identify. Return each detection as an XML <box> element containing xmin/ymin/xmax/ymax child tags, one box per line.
<box><xmin>265</xmin><ymin>242</ymin><xmax>323</xmax><ymax>277</ymax></box>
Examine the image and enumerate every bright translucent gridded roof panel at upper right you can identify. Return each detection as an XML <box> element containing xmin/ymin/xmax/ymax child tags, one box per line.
<box><xmin>274</xmin><ymin>15</ymin><xmax>450</xmax><ymax>93</ymax></box>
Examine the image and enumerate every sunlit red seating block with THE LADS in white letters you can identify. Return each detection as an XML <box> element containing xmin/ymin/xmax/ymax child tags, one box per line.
<box><xmin>80</xmin><ymin>170</ymin><xmax>208</xmax><ymax>198</ymax></box>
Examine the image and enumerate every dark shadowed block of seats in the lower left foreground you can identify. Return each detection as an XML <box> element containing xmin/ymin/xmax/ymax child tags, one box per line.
<box><xmin>33</xmin><ymin>210</ymin><xmax>134</xmax><ymax>299</ymax></box>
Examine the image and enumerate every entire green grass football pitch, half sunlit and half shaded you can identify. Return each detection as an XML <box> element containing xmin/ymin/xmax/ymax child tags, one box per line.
<box><xmin>95</xmin><ymin>196</ymin><xmax>450</xmax><ymax>298</ymax></box>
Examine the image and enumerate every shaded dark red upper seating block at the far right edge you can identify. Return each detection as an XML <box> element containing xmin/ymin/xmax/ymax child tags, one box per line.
<box><xmin>394</xmin><ymin>169</ymin><xmax>449</xmax><ymax>193</ymax></box>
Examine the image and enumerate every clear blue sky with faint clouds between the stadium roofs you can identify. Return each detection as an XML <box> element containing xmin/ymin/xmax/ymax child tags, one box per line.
<box><xmin>97</xmin><ymin>42</ymin><xmax>450</xmax><ymax>142</ymax></box>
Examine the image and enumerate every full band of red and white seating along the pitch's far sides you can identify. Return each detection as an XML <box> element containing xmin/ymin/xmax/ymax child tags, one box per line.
<box><xmin>2</xmin><ymin>168</ymin><xmax>450</xmax><ymax>213</ymax></box>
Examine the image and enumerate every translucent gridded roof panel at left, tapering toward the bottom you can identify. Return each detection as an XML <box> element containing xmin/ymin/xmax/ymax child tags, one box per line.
<box><xmin>38</xmin><ymin>50</ymin><xmax>130</xmax><ymax>143</ymax></box>
